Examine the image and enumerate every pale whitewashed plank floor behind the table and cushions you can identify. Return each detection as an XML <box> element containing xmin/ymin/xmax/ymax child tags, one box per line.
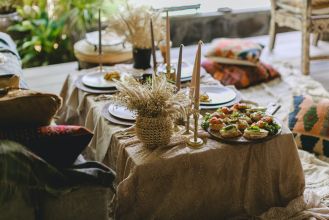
<box><xmin>23</xmin><ymin>32</ymin><xmax>329</xmax><ymax>94</ymax></box>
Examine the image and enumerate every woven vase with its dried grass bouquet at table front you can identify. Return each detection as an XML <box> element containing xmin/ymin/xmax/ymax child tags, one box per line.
<box><xmin>112</xmin><ymin>76</ymin><xmax>189</xmax><ymax>149</ymax></box>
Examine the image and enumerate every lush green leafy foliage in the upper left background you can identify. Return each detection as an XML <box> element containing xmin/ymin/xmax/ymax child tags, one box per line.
<box><xmin>8</xmin><ymin>0</ymin><xmax>121</xmax><ymax>67</ymax></box>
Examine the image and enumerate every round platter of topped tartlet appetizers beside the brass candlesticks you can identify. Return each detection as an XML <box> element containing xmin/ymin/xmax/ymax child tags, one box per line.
<box><xmin>202</xmin><ymin>103</ymin><xmax>281</xmax><ymax>144</ymax></box>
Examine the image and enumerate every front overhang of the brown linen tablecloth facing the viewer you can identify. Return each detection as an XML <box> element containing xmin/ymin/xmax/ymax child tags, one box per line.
<box><xmin>111</xmin><ymin>128</ymin><xmax>305</xmax><ymax>219</ymax></box>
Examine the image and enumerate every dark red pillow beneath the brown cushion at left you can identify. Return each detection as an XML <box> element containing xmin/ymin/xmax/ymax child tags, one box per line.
<box><xmin>0</xmin><ymin>125</ymin><xmax>93</xmax><ymax>168</ymax></box>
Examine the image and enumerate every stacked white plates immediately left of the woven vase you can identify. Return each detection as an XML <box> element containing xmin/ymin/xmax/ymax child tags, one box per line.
<box><xmin>102</xmin><ymin>103</ymin><xmax>136</xmax><ymax>126</ymax></box>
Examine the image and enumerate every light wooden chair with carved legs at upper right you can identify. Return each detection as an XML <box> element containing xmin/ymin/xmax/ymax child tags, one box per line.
<box><xmin>269</xmin><ymin>0</ymin><xmax>329</xmax><ymax>75</ymax></box>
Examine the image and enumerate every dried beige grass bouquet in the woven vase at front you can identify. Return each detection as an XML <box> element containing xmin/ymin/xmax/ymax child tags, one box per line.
<box><xmin>112</xmin><ymin>76</ymin><xmax>189</xmax><ymax>118</ymax></box>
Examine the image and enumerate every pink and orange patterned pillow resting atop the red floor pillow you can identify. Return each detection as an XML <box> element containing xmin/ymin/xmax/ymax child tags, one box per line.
<box><xmin>206</xmin><ymin>38</ymin><xmax>264</xmax><ymax>63</ymax></box>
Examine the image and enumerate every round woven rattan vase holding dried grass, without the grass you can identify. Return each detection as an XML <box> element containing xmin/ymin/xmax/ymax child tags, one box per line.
<box><xmin>136</xmin><ymin>116</ymin><xmax>173</xmax><ymax>150</ymax></box>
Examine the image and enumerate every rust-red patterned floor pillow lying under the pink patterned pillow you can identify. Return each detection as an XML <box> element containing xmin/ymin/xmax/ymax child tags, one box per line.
<box><xmin>202</xmin><ymin>60</ymin><xmax>280</xmax><ymax>89</ymax></box>
